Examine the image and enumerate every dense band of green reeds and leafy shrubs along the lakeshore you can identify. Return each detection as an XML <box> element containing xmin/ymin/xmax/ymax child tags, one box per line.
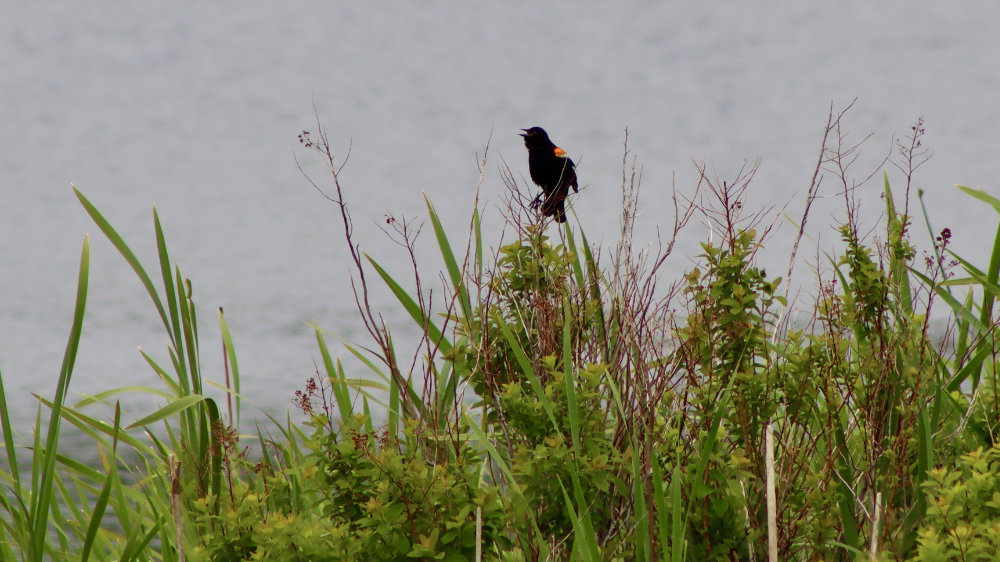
<box><xmin>0</xmin><ymin>111</ymin><xmax>1000</xmax><ymax>561</ymax></box>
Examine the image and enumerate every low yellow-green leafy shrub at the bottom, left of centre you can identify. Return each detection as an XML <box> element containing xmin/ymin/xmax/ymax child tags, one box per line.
<box><xmin>186</xmin><ymin>415</ymin><xmax>506</xmax><ymax>561</ymax></box>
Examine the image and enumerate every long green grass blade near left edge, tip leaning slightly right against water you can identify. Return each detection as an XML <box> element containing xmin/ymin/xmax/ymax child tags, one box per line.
<box><xmin>27</xmin><ymin>233</ymin><xmax>90</xmax><ymax>560</ymax></box>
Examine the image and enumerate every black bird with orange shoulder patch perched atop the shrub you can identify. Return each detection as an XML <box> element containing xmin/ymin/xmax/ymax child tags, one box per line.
<box><xmin>521</xmin><ymin>127</ymin><xmax>580</xmax><ymax>222</ymax></box>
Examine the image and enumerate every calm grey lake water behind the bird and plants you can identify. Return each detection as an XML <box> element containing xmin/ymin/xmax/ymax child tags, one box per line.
<box><xmin>0</xmin><ymin>0</ymin><xmax>1000</xmax><ymax>433</ymax></box>
